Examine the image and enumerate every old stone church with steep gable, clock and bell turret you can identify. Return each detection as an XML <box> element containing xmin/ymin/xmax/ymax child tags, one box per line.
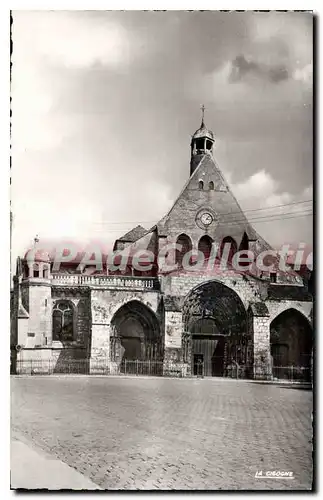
<box><xmin>11</xmin><ymin>114</ymin><xmax>313</xmax><ymax>379</ymax></box>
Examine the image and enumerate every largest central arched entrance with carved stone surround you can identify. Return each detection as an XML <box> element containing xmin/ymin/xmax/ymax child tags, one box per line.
<box><xmin>182</xmin><ymin>281</ymin><xmax>252</xmax><ymax>377</ymax></box>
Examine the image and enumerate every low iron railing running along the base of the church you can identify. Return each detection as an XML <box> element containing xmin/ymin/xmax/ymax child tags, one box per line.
<box><xmin>11</xmin><ymin>359</ymin><xmax>312</xmax><ymax>382</ymax></box>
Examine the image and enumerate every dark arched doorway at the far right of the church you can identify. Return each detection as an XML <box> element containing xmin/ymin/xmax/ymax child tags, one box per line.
<box><xmin>270</xmin><ymin>308</ymin><xmax>313</xmax><ymax>380</ymax></box>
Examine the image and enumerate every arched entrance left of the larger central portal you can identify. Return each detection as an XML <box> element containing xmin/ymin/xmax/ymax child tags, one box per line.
<box><xmin>110</xmin><ymin>300</ymin><xmax>163</xmax><ymax>372</ymax></box>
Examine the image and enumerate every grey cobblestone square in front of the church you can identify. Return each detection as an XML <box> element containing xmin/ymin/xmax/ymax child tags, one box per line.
<box><xmin>11</xmin><ymin>376</ymin><xmax>312</xmax><ymax>490</ymax></box>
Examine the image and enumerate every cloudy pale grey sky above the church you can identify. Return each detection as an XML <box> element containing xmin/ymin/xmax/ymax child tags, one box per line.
<box><xmin>11</xmin><ymin>11</ymin><xmax>313</xmax><ymax>266</ymax></box>
